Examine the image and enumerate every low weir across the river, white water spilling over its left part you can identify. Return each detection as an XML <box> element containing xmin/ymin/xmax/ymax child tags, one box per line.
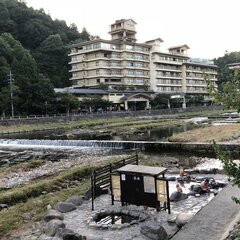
<box><xmin>0</xmin><ymin>139</ymin><xmax>240</xmax><ymax>156</ymax></box>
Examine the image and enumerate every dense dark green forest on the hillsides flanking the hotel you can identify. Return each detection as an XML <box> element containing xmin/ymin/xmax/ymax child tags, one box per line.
<box><xmin>0</xmin><ymin>0</ymin><xmax>240</xmax><ymax>116</ymax></box>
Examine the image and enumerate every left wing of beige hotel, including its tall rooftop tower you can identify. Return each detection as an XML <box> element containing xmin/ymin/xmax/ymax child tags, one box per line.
<box><xmin>69</xmin><ymin>19</ymin><xmax>151</xmax><ymax>89</ymax></box>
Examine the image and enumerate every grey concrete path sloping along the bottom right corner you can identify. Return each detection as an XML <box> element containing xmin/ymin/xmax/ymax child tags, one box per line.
<box><xmin>171</xmin><ymin>186</ymin><xmax>240</xmax><ymax>240</ymax></box>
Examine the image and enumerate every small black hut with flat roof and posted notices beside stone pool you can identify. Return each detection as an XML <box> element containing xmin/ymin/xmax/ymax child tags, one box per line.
<box><xmin>111</xmin><ymin>164</ymin><xmax>170</xmax><ymax>213</ymax></box>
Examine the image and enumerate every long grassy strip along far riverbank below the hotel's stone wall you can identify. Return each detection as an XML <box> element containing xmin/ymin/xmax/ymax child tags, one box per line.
<box><xmin>0</xmin><ymin>110</ymin><xmax>232</xmax><ymax>135</ymax></box>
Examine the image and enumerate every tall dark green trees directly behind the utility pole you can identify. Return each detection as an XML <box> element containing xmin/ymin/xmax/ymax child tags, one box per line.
<box><xmin>0</xmin><ymin>33</ymin><xmax>54</xmax><ymax>114</ymax></box>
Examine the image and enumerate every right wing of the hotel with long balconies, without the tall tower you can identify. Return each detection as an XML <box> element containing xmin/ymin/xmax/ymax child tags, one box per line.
<box><xmin>148</xmin><ymin>39</ymin><xmax>218</xmax><ymax>104</ymax></box>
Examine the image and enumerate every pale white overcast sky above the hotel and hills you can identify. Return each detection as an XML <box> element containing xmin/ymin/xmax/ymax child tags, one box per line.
<box><xmin>26</xmin><ymin>0</ymin><xmax>240</xmax><ymax>59</ymax></box>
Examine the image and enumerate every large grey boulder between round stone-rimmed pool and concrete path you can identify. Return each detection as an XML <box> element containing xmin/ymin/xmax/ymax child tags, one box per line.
<box><xmin>140</xmin><ymin>221</ymin><xmax>168</xmax><ymax>240</ymax></box>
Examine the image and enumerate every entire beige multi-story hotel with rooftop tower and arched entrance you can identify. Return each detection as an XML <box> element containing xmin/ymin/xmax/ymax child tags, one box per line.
<box><xmin>69</xmin><ymin>19</ymin><xmax>218</xmax><ymax>109</ymax></box>
